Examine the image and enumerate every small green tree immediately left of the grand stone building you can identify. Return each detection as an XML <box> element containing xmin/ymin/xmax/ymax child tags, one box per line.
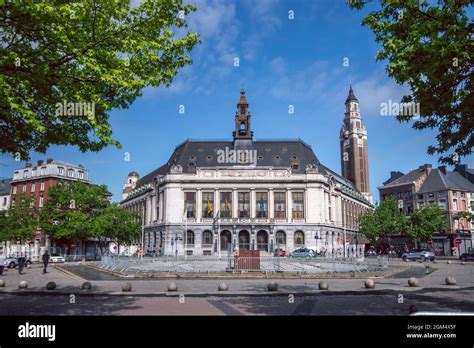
<box><xmin>95</xmin><ymin>204</ymin><xmax>141</xmax><ymax>254</ymax></box>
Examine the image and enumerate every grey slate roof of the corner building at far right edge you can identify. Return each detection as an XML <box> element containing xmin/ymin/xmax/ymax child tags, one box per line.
<box><xmin>418</xmin><ymin>168</ymin><xmax>474</xmax><ymax>193</ymax></box>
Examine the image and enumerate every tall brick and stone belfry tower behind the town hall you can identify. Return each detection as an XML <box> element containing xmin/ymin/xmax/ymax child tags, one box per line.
<box><xmin>339</xmin><ymin>85</ymin><xmax>372</xmax><ymax>203</ymax></box>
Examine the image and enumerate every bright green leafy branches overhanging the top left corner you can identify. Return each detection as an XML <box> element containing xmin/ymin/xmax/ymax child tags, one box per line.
<box><xmin>0</xmin><ymin>0</ymin><xmax>199</xmax><ymax>159</ymax></box>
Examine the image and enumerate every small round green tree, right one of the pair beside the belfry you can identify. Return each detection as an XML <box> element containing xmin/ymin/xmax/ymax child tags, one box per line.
<box><xmin>407</xmin><ymin>205</ymin><xmax>447</xmax><ymax>241</ymax></box>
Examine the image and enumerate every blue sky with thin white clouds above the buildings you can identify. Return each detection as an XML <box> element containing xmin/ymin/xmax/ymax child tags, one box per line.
<box><xmin>0</xmin><ymin>0</ymin><xmax>474</xmax><ymax>201</ymax></box>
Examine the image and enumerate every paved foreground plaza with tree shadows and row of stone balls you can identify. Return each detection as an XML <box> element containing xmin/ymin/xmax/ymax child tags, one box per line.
<box><xmin>0</xmin><ymin>261</ymin><xmax>474</xmax><ymax>315</ymax></box>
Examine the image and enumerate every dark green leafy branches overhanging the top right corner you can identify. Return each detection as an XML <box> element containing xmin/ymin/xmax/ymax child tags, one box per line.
<box><xmin>347</xmin><ymin>0</ymin><xmax>474</xmax><ymax>164</ymax></box>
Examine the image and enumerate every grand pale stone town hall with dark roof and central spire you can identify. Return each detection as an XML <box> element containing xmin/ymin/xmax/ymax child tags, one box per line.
<box><xmin>120</xmin><ymin>90</ymin><xmax>371</xmax><ymax>256</ymax></box>
